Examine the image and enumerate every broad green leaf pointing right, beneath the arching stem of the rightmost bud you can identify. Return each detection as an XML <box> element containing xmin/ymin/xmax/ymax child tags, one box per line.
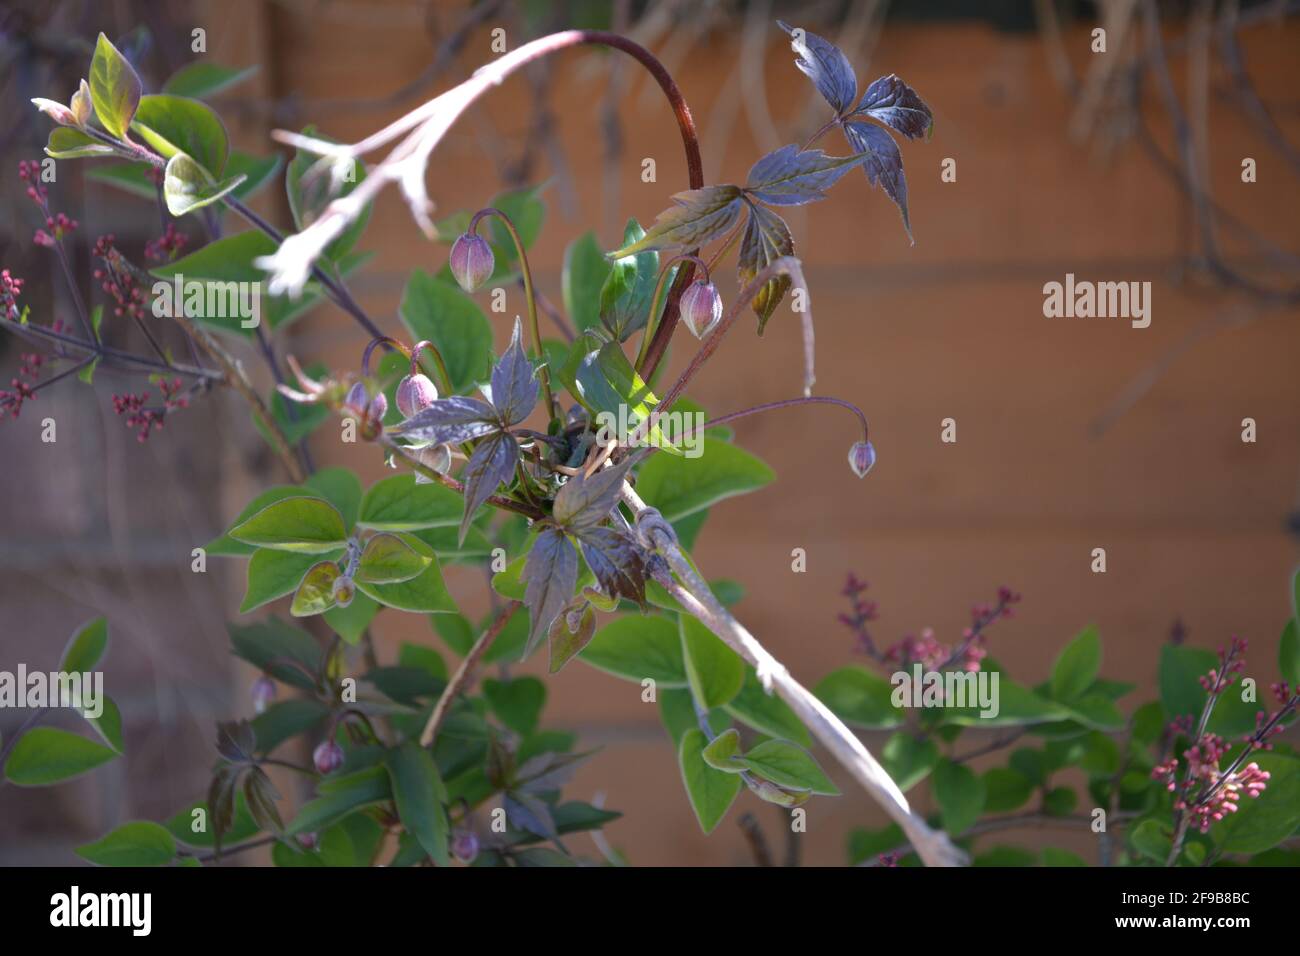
<box><xmin>637</xmin><ymin>438</ymin><xmax>776</xmax><ymax>522</ymax></box>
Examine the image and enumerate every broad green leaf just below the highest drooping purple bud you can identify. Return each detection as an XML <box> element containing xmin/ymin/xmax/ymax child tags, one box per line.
<box><xmin>400</xmin><ymin>269</ymin><xmax>493</xmax><ymax>393</ymax></box>
